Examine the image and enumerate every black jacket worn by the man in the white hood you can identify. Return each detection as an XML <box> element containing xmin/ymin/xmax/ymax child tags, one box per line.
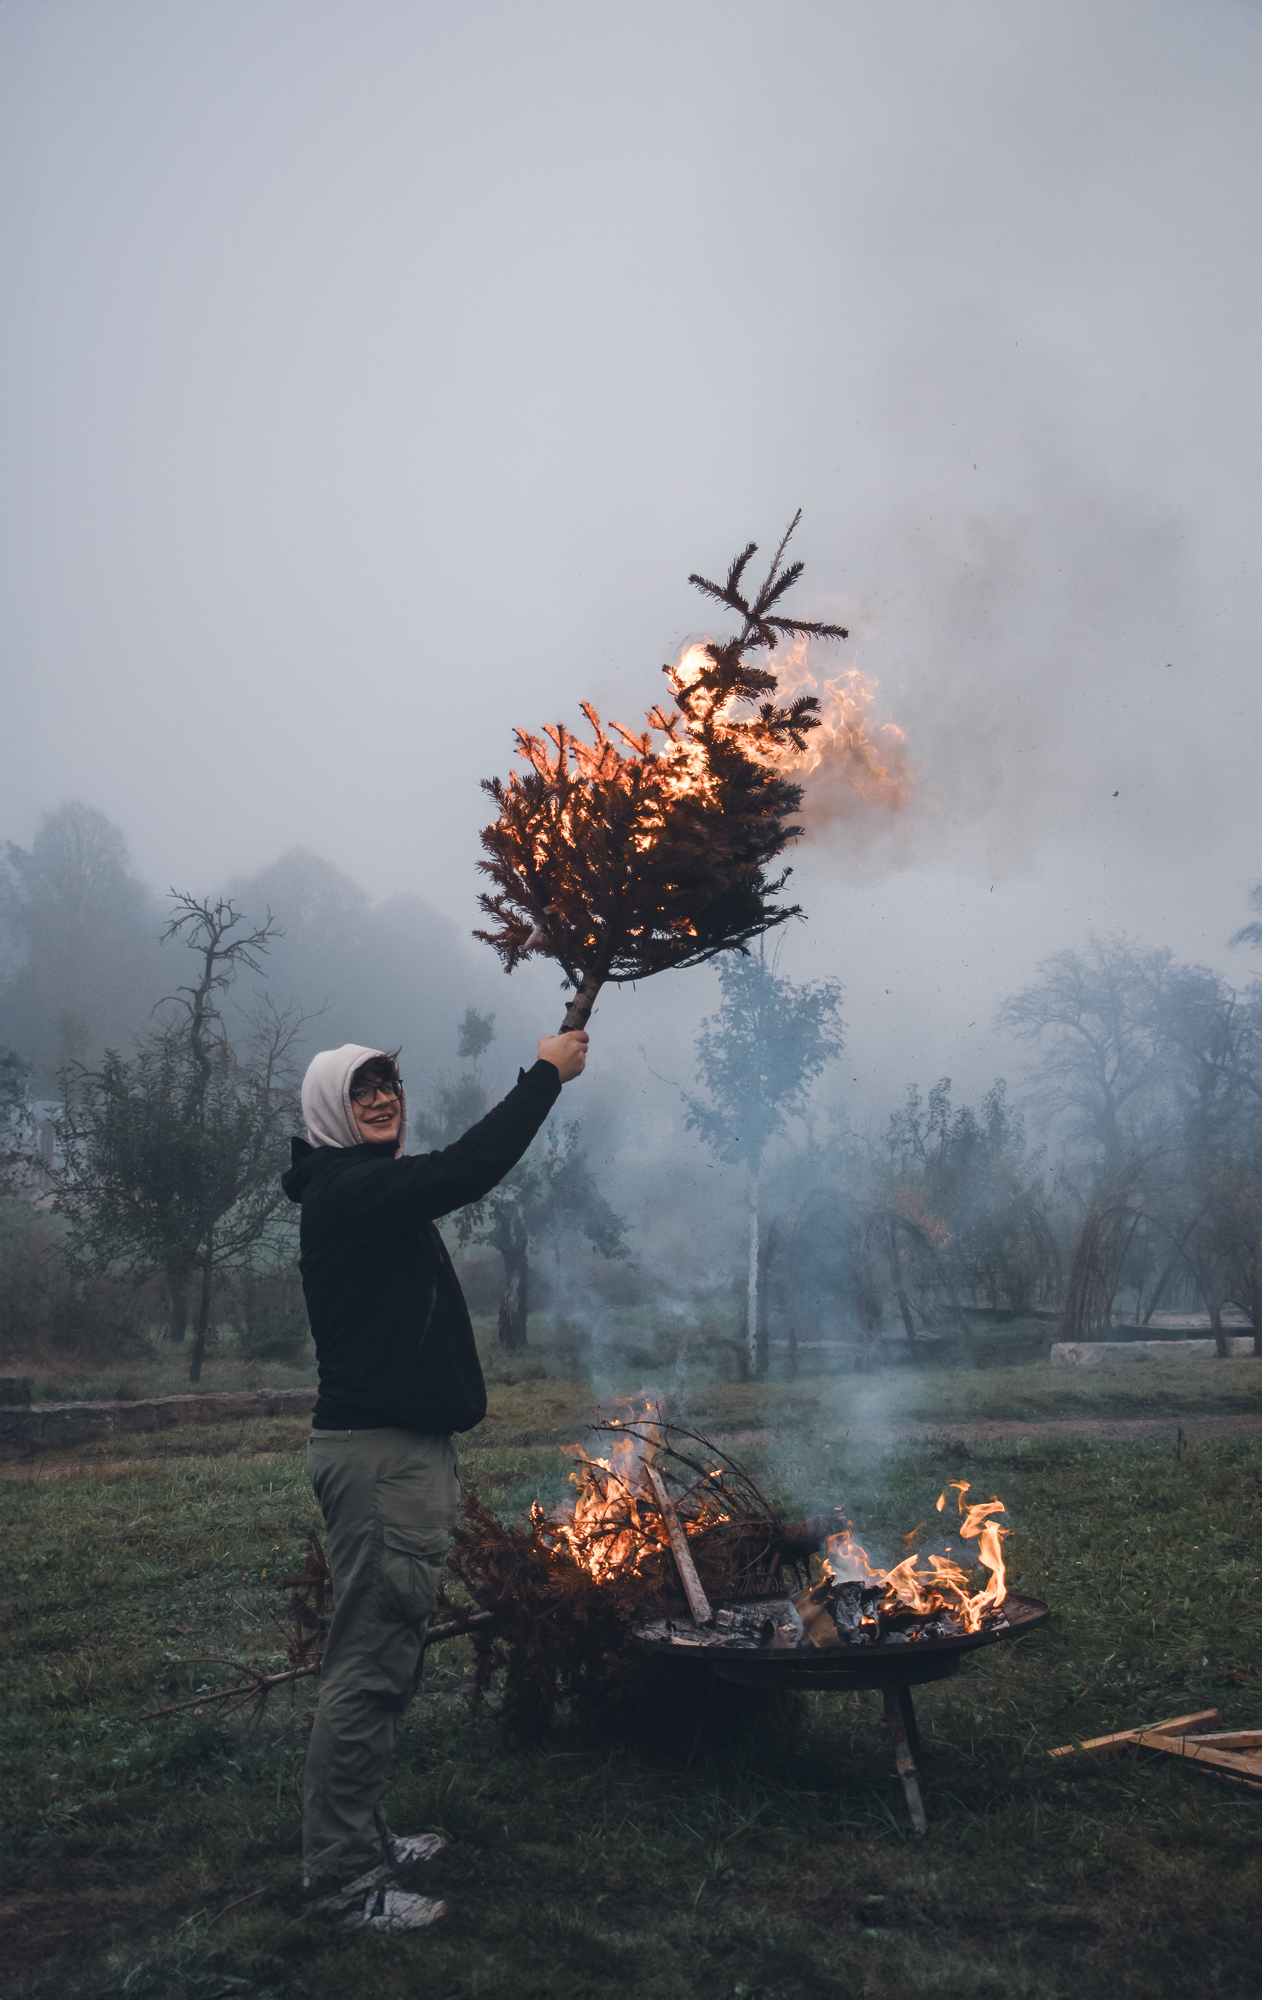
<box><xmin>282</xmin><ymin>1062</ymin><xmax>560</xmax><ymax>1434</ymax></box>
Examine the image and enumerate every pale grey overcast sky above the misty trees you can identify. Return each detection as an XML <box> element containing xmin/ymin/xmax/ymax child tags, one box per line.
<box><xmin>0</xmin><ymin>0</ymin><xmax>1262</xmax><ymax>1094</ymax></box>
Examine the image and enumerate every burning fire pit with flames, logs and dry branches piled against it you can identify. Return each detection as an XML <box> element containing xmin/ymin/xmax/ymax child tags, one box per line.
<box><xmin>454</xmin><ymin>1400</ymin><xmax>1048</xmax><ymax>1832</ymax></box>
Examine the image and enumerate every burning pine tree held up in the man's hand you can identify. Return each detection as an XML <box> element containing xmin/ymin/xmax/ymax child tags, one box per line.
<box><xmin>476</xmin><ymin>512</ymin><xmax>848</xmax><ymax>1028</ymax></box>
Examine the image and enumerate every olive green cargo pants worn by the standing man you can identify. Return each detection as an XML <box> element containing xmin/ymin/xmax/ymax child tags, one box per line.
<box><xmin>302</xmin><ymin>1430</ymin><xmax>460</xmax><ymax>1886</ymax></box>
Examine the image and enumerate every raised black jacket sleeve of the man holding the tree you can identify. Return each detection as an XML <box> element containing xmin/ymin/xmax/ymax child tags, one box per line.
<box><xmin>318</xmin><ymin>1062</ymin><xmax>560</xmax><ymax>1230</ymax></box>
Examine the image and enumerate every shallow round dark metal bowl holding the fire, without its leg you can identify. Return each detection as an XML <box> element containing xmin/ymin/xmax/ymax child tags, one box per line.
<box><xmin>636</xmin><ymin>1592</ymin><xmax>1050</xmax><ymax>1692</ymax></box>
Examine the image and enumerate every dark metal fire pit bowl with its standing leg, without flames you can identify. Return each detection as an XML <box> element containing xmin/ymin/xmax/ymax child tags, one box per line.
<box><xmin>636</xmin><ymin>1592</ymin><xmax>1048</xmax><ymax>1834</ymax></box>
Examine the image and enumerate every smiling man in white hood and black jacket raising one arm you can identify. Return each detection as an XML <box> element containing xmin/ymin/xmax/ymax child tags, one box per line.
<box><xmin>282</xmin><ymin>1032</ymin><xmax>588</xmax><ymax>1928</ymax></box>
